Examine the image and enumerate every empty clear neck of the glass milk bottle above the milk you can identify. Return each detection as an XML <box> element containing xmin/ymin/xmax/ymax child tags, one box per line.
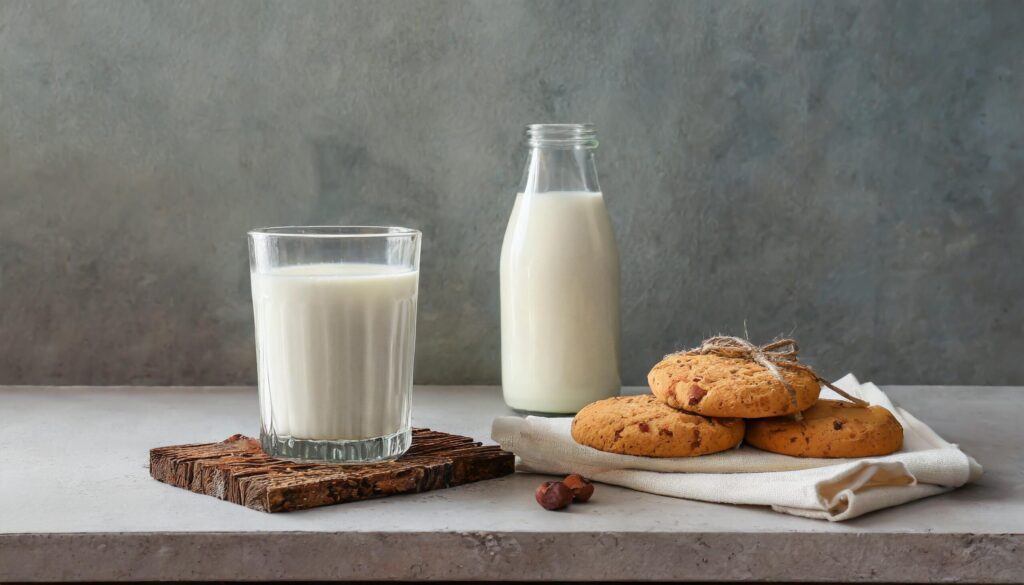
<box><xmin>519</xmin><ymin>124</ymin><xmax>601</xmax><ymax>194</ymax></box>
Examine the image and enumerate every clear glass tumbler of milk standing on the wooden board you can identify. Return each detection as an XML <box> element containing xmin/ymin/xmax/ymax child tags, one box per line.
<box><xmin>249</xmin><ymin>226</ymin><xmax>421</xmax><ymax>463</ymax></box>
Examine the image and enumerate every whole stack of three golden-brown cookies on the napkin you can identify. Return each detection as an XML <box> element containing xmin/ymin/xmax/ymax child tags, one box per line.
<box><xmin>572</xmin><ymin>340</ymin><xmax>903</xmax><ymax>457</ymax></box>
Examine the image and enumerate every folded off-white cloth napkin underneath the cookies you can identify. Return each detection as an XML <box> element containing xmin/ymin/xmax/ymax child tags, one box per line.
<box><xmin>492</xmin><ymin>374</ymin><xmax>982</xmax><ymax>521</ymax></box>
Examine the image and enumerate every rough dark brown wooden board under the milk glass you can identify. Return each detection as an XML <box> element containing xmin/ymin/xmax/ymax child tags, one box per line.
<box><xmin>150</xmin><ymin>428</ymin><xmax>515</xmax><ymax>512</ymax></box>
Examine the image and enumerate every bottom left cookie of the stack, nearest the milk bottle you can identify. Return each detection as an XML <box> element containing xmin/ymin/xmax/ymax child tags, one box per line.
<box><xmin>572</xmin><ymin>394</ymin><xmax>743</xmax><ymax>457</ymax></box>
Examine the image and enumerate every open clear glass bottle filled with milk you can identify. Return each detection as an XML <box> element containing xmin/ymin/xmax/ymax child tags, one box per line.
<box><xmin>501</xmin><ymin>124</ymin><xmax>621</xmax><ymax>414</ymax></box>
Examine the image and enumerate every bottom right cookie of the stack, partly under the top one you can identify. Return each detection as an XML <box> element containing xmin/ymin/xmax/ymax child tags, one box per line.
<box><xmin>746</xmin><ymin>400</ymin><xmax>903</xmax><ymax>458</ymax></box>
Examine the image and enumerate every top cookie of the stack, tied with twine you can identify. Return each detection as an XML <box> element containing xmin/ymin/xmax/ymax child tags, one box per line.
<box><xmin>647</xmin><ymin>354</ymin><xmax>821</xmax><ymax>418</ymax></box>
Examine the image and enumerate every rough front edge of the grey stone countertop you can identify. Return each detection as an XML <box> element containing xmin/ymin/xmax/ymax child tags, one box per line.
<box><xmin>0</xmin><ymin>532</ymin><xmax>1024</xmax><ymax>583</ymax></box>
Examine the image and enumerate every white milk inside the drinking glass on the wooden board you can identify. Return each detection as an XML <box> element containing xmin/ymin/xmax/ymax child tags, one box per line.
<box><xmin>252</xmin><ymin>263</ymin><xmax>419</xmax><ymax>441</ymax></box>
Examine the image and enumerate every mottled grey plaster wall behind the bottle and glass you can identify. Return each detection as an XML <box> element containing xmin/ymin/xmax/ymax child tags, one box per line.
<box><xmin>0</xmin><ymin>0</ymin><xmax>1024</xmax><ymax>384</ymax></box>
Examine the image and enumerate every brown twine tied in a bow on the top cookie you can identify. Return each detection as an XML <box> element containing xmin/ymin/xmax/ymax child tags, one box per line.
<box><xmin>675</xmin><ymin>335</ymin><xmax>867</xmax><ymax>420</ymax></box>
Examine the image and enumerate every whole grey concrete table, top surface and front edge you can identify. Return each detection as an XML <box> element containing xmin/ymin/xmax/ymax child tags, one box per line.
<box><xmin>0</xmin><ymin>386</ymin><xmax>1024</xmax><ymax>582</ymax></box>
